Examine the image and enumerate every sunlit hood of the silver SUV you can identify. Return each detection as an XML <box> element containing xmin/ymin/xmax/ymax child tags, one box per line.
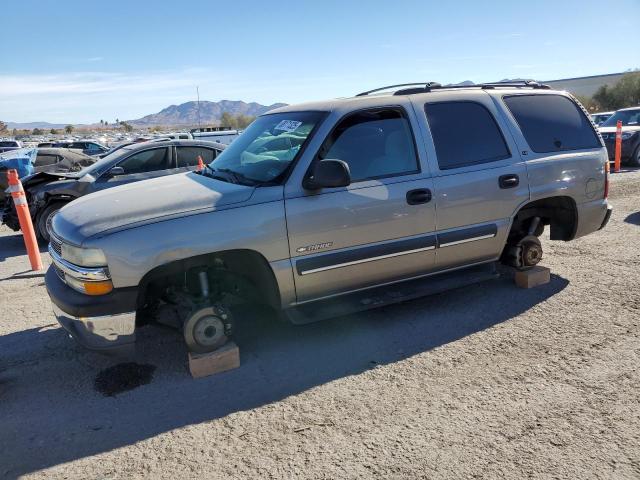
<box><xmin>53</xmin><ymin>172</ymin><xmax>255</xmax><ymax>245</ymax></box>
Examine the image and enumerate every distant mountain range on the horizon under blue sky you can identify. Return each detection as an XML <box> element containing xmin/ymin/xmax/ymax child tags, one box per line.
<box><xmin>7</xmin><ymin>100</ymin><xmax>286</xmax><ymax>130</ymax></box>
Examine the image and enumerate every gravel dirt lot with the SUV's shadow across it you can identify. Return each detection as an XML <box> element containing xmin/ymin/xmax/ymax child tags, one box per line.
<box><xmin>0</xmin><ymin>172</ymin><xmax>640</xmax><ymax>479</ymax></box>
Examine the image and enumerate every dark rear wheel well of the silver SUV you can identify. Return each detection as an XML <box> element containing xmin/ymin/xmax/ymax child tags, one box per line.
<box><xmin>509</xmin><ymin>197</ymin><xmax>578</xmax><ymax>241</ymax></box>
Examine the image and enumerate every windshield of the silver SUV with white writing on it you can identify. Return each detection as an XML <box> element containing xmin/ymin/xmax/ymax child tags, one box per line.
<box><xmin>205</xmin><ymin>112</ymin><xmax>324</xmax><ymax>184</ymax></box>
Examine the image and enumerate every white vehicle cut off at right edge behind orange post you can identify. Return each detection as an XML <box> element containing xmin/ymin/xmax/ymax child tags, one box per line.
<box><xmin>598</xmin><ymin>107</ymin><xmax>640</xmax><ymax>167</ymax></box>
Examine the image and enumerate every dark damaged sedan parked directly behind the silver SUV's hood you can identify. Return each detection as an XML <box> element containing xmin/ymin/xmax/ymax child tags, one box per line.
<box><xmin>3</xmin><ymin>140</ymin><xmax>225</xmax><ymax>242</ymax></box>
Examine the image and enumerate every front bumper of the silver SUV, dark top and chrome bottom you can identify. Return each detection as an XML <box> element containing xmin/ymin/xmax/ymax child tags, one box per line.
<box><xmin>45</xmin><ymin>267</ymin><xmax>137</xmax><ymax>350</ymax></box>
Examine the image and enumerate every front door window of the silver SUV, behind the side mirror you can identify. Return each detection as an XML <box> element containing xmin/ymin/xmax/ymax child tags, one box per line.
<box><xmin>319</xmin><ymin>109</ymin><xmax>419</xmax><ymax>182</ymax></box>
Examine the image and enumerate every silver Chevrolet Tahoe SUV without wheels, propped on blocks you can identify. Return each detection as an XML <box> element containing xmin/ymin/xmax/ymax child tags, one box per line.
<box><xmin>46</xmin><ymin>83</ymin><xmax>611</xmax><ymax>352</ymax></box>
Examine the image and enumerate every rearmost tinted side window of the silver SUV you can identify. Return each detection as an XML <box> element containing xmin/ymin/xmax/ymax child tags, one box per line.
<box><xmin>504</xmin><ymin>95</ymin><xmax>601</xmax><ymax>153</ymax></box>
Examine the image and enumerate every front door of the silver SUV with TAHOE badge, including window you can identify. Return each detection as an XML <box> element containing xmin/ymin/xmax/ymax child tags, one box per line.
<box><xmin>285</xmin><ymin>106</ymin><xmax>436</xmax><ymax>302</ymax></box>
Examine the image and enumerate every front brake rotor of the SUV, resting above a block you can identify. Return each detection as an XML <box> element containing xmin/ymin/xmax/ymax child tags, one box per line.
<box><xmin>183</xmin><ymin>307</ymin><xmax>228</xmax><ymax>353</ymax></box>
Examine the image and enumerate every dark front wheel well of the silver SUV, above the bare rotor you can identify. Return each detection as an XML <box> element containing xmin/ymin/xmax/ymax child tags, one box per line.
<box><xmin>138</xmin><ymin>250</ymin><xmax>280</xmax><ymax>308</ymax></box>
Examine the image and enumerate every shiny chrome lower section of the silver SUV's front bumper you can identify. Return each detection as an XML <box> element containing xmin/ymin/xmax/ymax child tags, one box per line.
<box><xmin>53</xmin><ymin>303</ymin><xmax>136</xmax><ymax>350</ymax></box>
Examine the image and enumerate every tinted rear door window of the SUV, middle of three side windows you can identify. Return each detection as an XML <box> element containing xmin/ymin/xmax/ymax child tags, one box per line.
<box><xmin>424</xmin><ymin>102</ymin><xmax>511</xmax><ymax>170</ymax></box>
